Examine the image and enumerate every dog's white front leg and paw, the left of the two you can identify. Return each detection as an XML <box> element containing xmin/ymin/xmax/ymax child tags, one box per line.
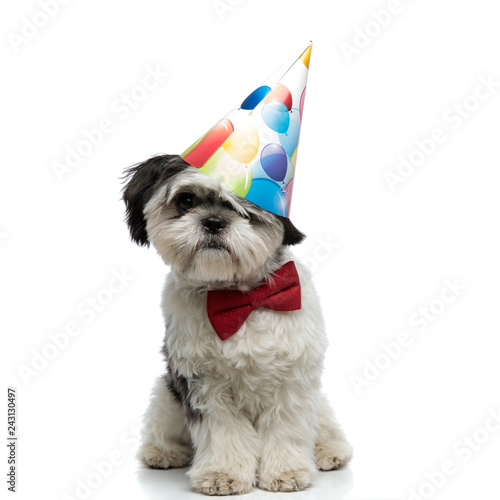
<box><xmin>188</xmin><ymin>401</ymin><xmax>259</xmax><ymax>495</ymax></box>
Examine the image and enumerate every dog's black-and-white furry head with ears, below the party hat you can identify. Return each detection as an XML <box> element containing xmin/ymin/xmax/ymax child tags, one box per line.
<box><xmin>123</xmin><ymin>155</ymin><xmax>304</xmax><ymax>282</ymax></box>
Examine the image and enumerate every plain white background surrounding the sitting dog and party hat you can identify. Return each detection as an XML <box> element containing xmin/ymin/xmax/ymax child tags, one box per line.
<box><xmin>0</xmin><ymin>0</ymin><xmax>500</xmax><ymax>499</ymax></box>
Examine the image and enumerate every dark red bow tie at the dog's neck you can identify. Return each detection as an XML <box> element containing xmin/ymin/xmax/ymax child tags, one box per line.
<box><xmin>207</xmin><ymin>261</ymin><xmax>301</xmax><ymax>340</ymax></box>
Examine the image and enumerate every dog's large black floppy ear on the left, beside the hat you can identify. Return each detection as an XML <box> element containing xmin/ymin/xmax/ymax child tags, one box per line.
<box><xmin>123</xmin><ymin>155</ymin><xmax>187</xmax><ymax>246</ymax></box>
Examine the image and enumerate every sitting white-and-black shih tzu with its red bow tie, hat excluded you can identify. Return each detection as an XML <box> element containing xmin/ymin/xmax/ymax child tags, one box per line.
<box><xmin>123</xmin><ymin>155</ymin><xmax>352</xmax><ymax>495</ymax></box>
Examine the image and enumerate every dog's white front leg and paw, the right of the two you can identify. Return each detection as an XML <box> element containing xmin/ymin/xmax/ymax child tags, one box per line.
<box><xmin>256</xmin><ymin>384</ymin><xmax>317</xmax><ymax>491</ymax></box>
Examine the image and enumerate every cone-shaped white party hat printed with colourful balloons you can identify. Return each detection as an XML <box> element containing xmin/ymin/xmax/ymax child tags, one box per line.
<box><xmin>181</xmin><ymin>43</ymin><xmax>312</xmax><ymax>217</ymax></box>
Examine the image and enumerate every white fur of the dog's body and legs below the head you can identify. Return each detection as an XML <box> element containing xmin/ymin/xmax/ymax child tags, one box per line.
<box><xmin>140</xmin><ymin>251</ymin><xmax>352</xmax><ymax>495</ymax></box>
